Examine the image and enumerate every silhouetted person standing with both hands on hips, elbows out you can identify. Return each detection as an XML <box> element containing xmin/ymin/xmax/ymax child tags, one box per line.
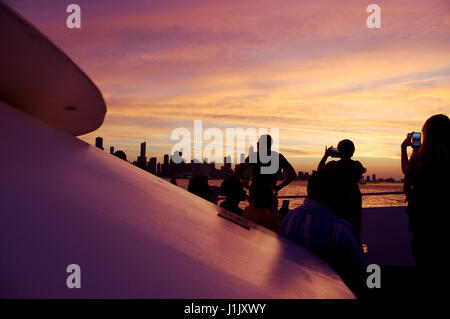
<box><xmin>236</xmin><ymin>135</ymin><xmax>297</xmax><ymax>213</ymax></box>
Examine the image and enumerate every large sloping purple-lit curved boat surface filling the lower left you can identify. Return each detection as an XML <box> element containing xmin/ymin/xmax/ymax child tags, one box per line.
<box><xmin>0</xmin><ymin>102</ymin><xmax>354</xmax><ymax>298</ymax></box>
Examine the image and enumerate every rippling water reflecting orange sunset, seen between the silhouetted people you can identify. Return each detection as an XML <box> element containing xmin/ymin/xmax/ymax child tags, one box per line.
<box><xmin>167</xmin><ymin>179</ymin><xmax>405</xmax><ymax>209</ymax></box>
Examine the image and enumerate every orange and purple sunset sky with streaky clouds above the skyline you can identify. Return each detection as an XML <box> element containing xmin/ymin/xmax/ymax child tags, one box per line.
<box><xmin>4</xmin><ymin>0</ymin><xmax>450</xmax><ymax>178</ymax></box>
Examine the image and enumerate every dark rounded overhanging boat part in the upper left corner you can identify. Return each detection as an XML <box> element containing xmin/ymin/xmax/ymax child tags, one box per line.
<box><xmin>0</xmin><ymin>2</ymin><xmax>106</xmax><ymax>136</ymax></box>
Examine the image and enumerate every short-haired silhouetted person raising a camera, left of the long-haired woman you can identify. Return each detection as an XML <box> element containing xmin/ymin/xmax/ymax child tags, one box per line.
<box><xmin>317</xmin><ymin>140</ymin><xmax>366</xmax><ymax>231</ymax></box>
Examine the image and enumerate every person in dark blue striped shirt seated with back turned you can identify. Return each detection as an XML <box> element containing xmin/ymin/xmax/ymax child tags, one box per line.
<box><xmin>281</xmin><ymin>171</ymin><xmax>368</xmax><ymax>297</ymax></box>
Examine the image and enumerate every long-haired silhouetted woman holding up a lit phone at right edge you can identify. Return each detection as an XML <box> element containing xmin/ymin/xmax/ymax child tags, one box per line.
<box><xmin>401</xmin><ymin>114</ymin><xmax>450</xmax><ymax>293</ymax></box>
